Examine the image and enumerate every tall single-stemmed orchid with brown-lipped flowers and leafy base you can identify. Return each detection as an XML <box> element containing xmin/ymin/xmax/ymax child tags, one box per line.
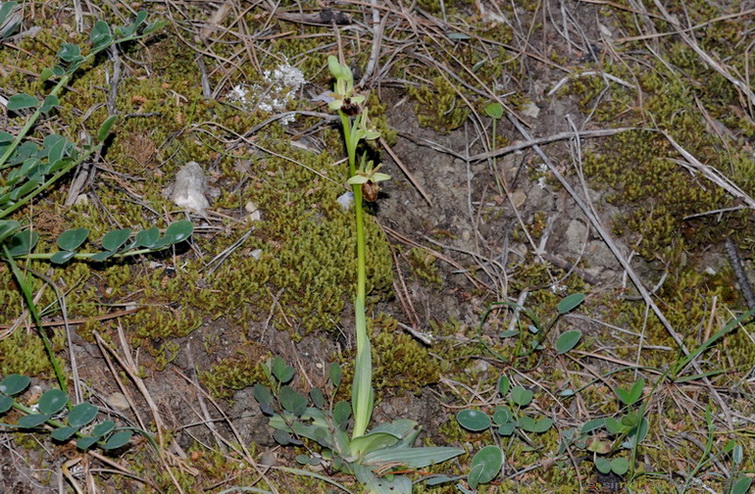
<box><xmin>254</xmin><ymin>56</ymin><xmax>464</xmax><ymax>494</ymax></box>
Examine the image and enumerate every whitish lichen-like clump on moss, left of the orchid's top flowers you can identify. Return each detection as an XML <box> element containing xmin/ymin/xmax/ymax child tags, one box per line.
<box><xmin>226</xmin><ymin>63</ymin><xmax>307</xmax><ymax>125</ymax></box>
